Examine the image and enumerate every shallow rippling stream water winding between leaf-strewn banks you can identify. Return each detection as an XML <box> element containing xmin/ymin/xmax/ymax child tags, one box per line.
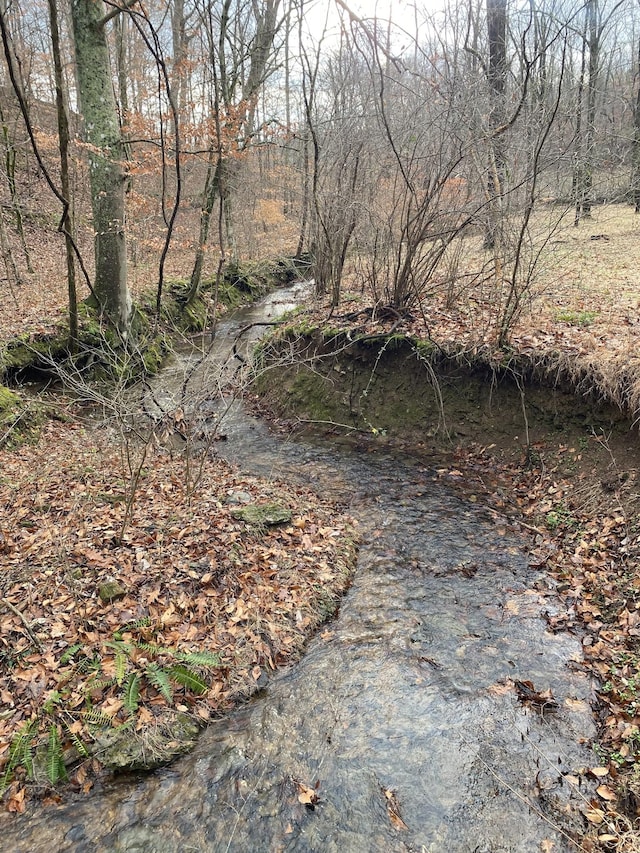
<box><xmin>0</xmin><ymin>293</ymin><xmax>596</xmax><ymax>853</ymax></box>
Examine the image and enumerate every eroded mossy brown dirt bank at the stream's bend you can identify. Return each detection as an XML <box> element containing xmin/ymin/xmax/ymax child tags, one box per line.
<box><xmin>255</xmin><ymin>329</ymin><xmax>637</xmax><ymax>466</ymax></box>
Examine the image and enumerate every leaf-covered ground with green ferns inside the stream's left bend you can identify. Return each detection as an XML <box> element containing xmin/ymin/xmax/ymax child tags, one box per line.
<box><xmin>0</xmin><ymin>420</ymin><xmax>354</xmax><ymax>811</ymax></box>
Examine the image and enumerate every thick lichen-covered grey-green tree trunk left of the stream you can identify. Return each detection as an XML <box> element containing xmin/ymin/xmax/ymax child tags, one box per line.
<box><xmin>71</xmin><ymin>0</ymin><xmax>131</xmax><ymax>334</ymax></box>
